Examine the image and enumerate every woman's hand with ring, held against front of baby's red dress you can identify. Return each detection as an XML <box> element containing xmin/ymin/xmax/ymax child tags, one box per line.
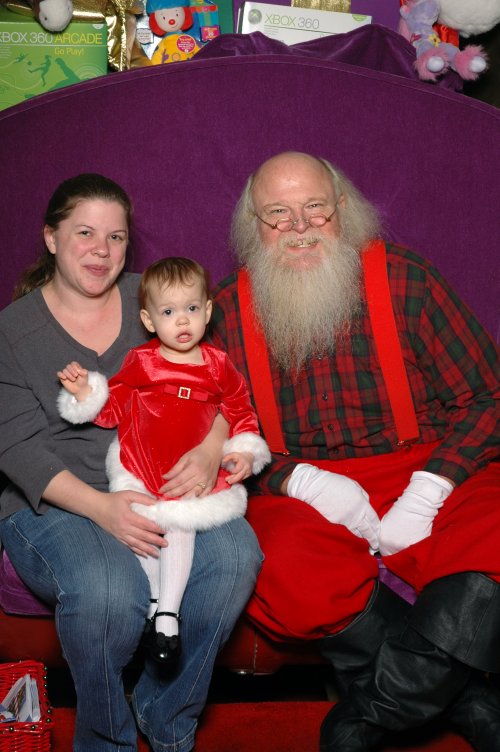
<box><xmin>160</xmin><ymin>414</ymin><xmax>228</xmax><ymax>498</ymax></box>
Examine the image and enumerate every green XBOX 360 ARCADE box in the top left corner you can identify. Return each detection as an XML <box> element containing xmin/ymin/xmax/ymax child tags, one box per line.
<box><xmin>0</xmin><ymin>8</ymin><xmax>108</xmax><ymax>110</ymax></box>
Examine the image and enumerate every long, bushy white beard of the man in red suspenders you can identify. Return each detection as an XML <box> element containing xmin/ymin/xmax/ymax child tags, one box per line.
<box><xmin>247</xmin><ymin>235</ymin><xmax>362</xmax><ymax>373</ymax></box>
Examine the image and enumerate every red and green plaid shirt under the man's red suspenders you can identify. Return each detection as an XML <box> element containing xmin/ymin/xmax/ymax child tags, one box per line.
<box><xmin>212</xmin><ymin>245</ymin><xmax>500</xmax><ymax>494</ymax></box>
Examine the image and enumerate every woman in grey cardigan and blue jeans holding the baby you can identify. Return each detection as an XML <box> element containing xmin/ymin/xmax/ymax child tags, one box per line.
<box><xmin>0</xmin><ymin>174</ymin><xmax>260</xmax><ymax>752</ymax></box>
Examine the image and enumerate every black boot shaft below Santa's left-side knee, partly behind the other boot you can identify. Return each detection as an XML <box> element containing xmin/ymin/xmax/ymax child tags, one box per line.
<box><xmin>319</xmin><ymin>581</ymin><xmax>411</xmax><ymax>698</ymax></box>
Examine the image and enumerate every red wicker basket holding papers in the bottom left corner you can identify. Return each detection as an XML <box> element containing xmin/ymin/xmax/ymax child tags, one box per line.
<box><xmin>0</xmin><ymin>661</ymin><xmax>54</xmax><ymax>752</ymax></box>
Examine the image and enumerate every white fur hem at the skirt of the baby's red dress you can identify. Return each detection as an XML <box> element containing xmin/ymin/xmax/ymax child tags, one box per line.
<box><xmin>106</xmin><ymin>438</ymin><xmax>247</xmax><ymax>531</ymax></box>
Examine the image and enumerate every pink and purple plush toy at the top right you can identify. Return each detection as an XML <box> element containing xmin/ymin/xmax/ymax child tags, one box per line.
<box><xmin>399</xmin><ymin>0</ymin><xmax>487</xmax><ymax>81</ymax></box>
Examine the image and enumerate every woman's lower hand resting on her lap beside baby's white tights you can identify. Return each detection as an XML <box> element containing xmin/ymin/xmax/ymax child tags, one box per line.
<box><xmin>92</xmin><ymin>491</ymin><xmax>168</xmax><ymax>558</ymax></box>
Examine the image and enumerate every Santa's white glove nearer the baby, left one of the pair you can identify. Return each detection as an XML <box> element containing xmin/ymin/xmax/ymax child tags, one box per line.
<box><xmin>288</xmin><ymin>464</ymin><xmax>380</xmax><ymax>551</ymax></box>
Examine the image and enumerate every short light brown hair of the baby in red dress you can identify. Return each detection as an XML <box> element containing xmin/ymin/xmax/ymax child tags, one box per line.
<box><xmin>139</xmin><ymin>256</ymin><xmax>210</xmax><ymax>308</ymax></box>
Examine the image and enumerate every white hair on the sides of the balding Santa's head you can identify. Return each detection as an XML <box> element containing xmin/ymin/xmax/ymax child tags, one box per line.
<box><xmin>231</xmin><ymin>152</ymin><xmax>381</xmax><ymax>264</ymax></box>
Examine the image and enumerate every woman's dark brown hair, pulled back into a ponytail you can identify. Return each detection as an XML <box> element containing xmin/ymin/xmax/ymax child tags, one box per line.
<box><xmin>13</xmin><ymin>172</ymin><xmax>132</xmax><ymax>300</ymax></box>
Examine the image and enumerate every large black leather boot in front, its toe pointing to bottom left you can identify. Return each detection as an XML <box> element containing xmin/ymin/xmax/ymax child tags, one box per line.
<box><xmin>321</xmin><ymin>572</ymin><xmax>500</xmax><ymax>752</ymax></box>
